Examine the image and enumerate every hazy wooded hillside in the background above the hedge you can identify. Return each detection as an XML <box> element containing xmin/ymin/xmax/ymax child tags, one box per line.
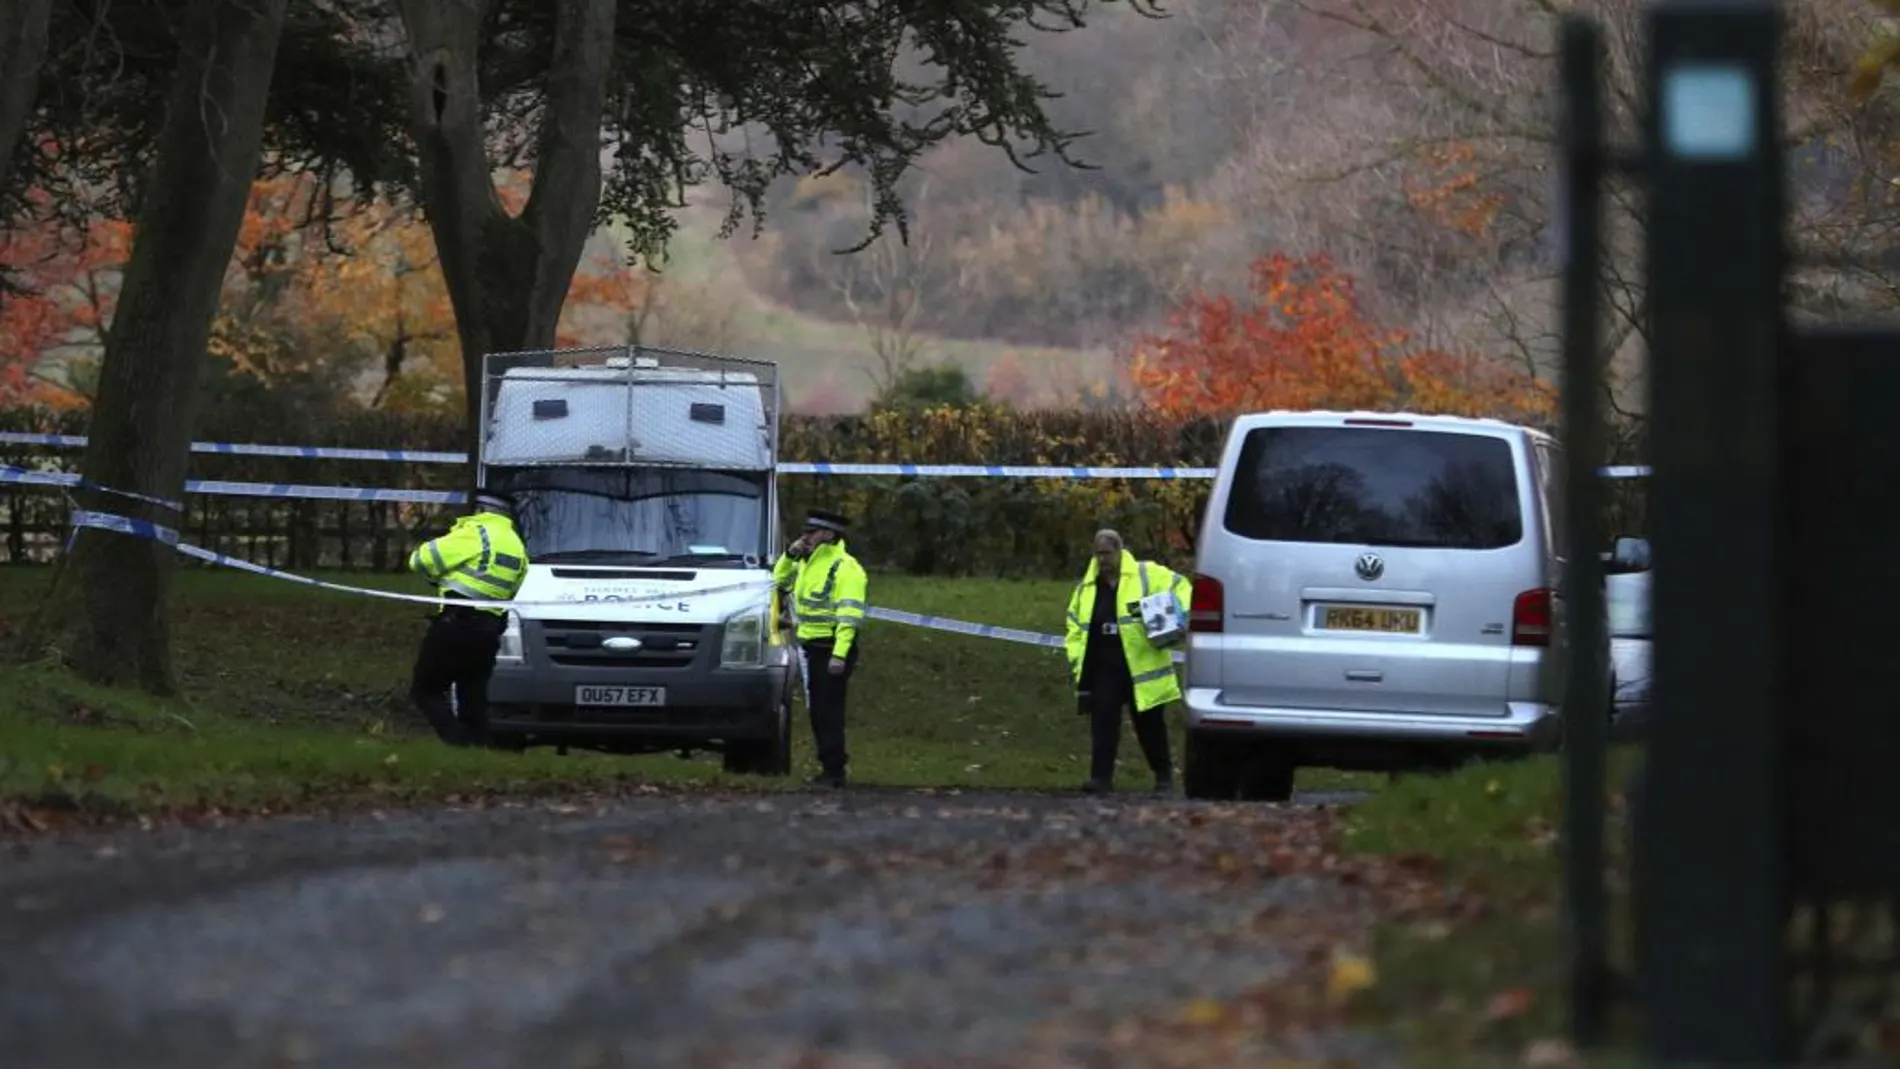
<box><xmin>596</xmin><ymin>0</ymin><xmax>1900</xmax><ymax>427</ymax></box>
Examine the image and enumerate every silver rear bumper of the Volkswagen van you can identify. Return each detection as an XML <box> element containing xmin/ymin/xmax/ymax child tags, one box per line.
<box><xmin>1182</xmin><ymin>687</ymin><xmax>1564</xmax><ymax>750</ymax></box>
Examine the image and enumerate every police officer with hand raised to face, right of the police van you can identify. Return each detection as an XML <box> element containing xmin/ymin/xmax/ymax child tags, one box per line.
<box><xmin>771</xmin><ymin>509</ymin><xmax>866</xmax><ymax>788</ymax></box>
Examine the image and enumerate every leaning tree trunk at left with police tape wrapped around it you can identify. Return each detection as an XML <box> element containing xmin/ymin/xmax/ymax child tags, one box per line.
<box><xmin>27</xmin><ymin>0</ymin><xmax>285</xmax><ymax>693</ymax></box>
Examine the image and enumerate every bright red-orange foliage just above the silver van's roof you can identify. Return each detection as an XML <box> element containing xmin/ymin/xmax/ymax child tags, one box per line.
<box><xmin>1131</xmin><ymin>254</ymin><xmax>1554</xmax><ymax>423</ymax></box>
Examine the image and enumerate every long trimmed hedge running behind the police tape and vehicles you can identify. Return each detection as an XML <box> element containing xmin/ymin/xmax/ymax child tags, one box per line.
<box><xmin>0</xmin><ymin>408</ymin><xmax>1632</xmax><ymax>575</ymax></box>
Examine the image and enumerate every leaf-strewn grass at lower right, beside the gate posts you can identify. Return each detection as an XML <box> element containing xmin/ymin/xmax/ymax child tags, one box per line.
<box><xmin>1343</xmin><ymin>748</ymin><xmax>1638</xmax><ymax>1069</ymax></box>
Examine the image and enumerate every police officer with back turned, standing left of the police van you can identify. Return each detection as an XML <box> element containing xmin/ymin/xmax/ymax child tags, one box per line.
<box><xmin>409</xmin><ymin>490</ymin><xmax>528</xmax><ymax>746</ymax></box>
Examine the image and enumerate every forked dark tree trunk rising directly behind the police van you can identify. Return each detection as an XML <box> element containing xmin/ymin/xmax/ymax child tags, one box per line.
<box><xmin>399</xmin><ymin>0</ymin><xmax>616</xmax><ymax>444</ymax></box>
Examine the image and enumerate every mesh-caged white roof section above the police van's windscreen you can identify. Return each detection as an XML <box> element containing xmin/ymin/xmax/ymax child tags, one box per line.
<box><xmin>479</xmin><ymin>346</ymin><xmax>779</xmax><ymax>471</ymax></box>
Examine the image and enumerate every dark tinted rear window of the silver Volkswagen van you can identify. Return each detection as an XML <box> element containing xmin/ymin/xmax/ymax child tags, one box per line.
<box><xmin>1222</xmin><ymin>427</ymin><xmax>1524</xmax><ymax>549</ymax></box>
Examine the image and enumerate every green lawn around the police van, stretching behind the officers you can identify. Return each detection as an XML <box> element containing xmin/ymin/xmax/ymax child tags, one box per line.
<box><xmin>0</xmin><ymin>568</ymin><xmax>1351</xmax><ymax>813</ymax></box>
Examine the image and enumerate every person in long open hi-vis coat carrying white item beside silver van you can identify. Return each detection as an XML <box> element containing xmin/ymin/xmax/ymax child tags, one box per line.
<box><xmin>1064</xmin><ymin>530</ymin><xmax>1189</xmax><ymax>794</ymax></box>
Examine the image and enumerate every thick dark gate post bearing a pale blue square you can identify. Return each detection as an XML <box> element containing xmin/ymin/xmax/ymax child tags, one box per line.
<box><xmin>1636</xmin><ymin>0</ymin><xmax>1788</xmax><ymax>1065</ymax></box>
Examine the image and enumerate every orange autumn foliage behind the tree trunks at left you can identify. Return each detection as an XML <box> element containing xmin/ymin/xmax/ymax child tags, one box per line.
<box><xmin>0</xmin><ymin>175</ymin><xmax>644</xmax><ymax>412</ymax></box>
